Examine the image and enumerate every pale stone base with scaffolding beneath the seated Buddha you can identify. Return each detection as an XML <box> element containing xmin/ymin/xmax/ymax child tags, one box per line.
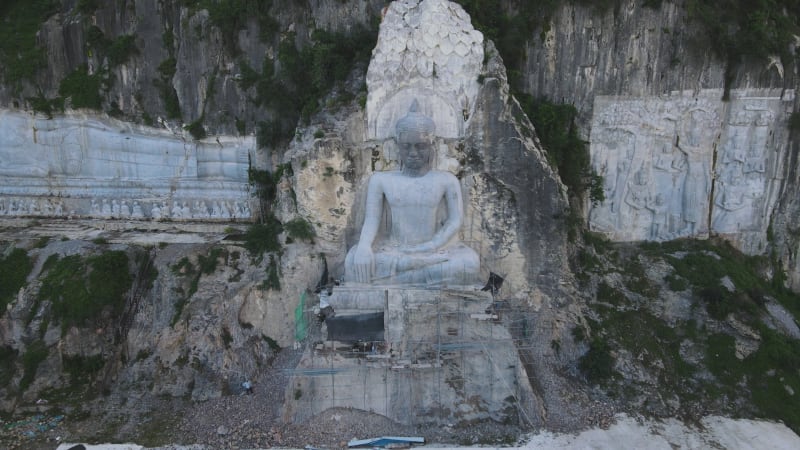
<box><xmin>287</xmin><ymin>290</ymin><xmax>540</xmax><ymax>426</ymax></box>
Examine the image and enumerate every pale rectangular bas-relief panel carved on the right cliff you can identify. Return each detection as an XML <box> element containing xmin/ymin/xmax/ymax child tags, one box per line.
<box><xmin>589</xmin><ymin>91</ymin><xmax>785</xmax><ymax>246</ymax></box>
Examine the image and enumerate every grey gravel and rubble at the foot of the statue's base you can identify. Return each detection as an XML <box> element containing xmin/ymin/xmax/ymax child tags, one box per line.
<box><xmin>165</xmin><ymin>342</ymin><xmax>522</xmax><ymax>449</ymax></box>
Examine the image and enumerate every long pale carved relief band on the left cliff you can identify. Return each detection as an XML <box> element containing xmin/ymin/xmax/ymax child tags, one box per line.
<box><xmin>0</xmin><ymin>110</ymin><xmax>255</xmax><ymax>221</ymax></box>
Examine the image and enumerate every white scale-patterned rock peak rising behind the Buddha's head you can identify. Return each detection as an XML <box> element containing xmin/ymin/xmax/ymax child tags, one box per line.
<box><xmin>367</xmin><ymin>0</ymin><xmax>483</xmax><ymax>139</ymax></box>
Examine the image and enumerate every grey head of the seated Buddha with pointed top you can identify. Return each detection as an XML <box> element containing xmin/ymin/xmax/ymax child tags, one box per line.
<box><xmin>396</xmin><ymin>100</ymin><xmax>436</xmax><ymax>175</ymax></box>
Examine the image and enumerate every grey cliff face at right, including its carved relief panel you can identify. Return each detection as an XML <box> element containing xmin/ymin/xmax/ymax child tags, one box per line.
<box><xmin>521</xmin><ymin>1</ymin><xmax>800</xmax><ymax>289</ymax></box>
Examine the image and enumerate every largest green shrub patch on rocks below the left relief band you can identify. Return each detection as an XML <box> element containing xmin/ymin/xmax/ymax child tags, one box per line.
<box><xmin>38</xmin><ymin>251</ymin><xmax>132</xmax><ymax>331</ymax></box>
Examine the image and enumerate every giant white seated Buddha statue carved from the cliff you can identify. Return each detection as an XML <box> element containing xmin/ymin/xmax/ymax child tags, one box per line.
<box><xmin>345</xmin><ymin>100</ymin><xmax>480</xmax><ymax>286</ymax></box>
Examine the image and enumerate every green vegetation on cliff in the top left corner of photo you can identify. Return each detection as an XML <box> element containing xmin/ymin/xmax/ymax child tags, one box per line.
<box><xmin>0</xmin><ymin>0</ymin><xmax>60</xmax><ymax>90</ymax></box>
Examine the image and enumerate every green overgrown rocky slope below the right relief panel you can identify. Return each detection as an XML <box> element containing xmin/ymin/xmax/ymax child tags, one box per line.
<box><xmin>573</xmin><ymin>239</ymin><xmax>800</xmax><ymax>430</ymax></box>
